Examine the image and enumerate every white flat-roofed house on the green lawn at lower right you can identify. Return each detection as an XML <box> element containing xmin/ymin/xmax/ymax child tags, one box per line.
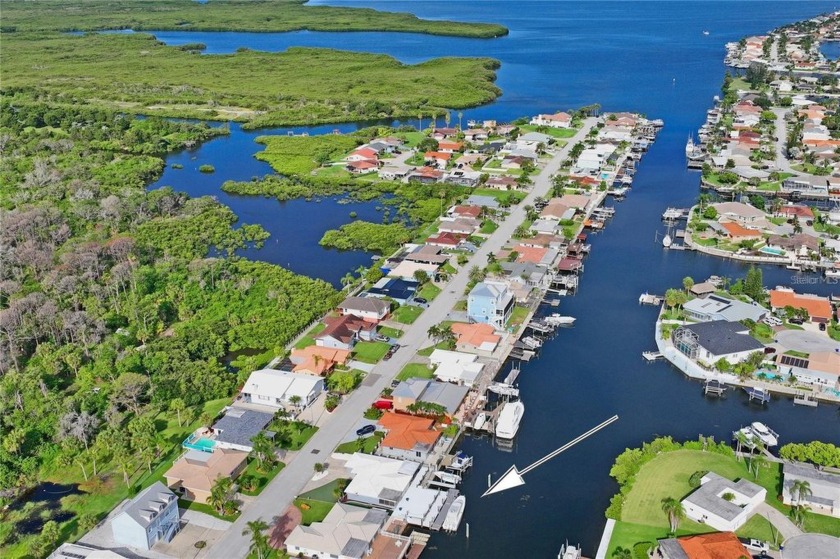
<box><xmin>682</xmin><ymin>472</ymin><xmax>767</xmax><ymax>532</ymax></box>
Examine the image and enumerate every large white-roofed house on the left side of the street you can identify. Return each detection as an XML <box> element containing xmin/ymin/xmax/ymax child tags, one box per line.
<box><xmin>242</xmin><ymin>369</ymin><xmax>324</xmax><ymax>409</ymax></box>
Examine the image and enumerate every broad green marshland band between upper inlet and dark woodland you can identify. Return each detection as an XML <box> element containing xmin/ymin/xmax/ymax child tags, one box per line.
<box><xmin>3</xmin><ymin>32</ymin><xmax>500</xmax><ymax>127</ymax></box>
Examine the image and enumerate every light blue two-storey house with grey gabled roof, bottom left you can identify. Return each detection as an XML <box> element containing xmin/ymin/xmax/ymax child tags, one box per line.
<box><xmin>111</xmin><ymin>481</ymin><xmax>181</xmax><ymax>550</ymax></box>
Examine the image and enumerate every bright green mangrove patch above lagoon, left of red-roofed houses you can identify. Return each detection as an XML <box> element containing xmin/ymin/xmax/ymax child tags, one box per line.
<box><xmin>256</xmin><ymin>134</ymin><xmax>360</xmax><ymax>175</ymax></box>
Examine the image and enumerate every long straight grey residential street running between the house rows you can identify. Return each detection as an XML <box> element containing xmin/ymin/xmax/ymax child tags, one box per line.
<box><xmin>208</xmin><ymin>118</ymin><xmax>596</xmax><ymax>559</ymax></box>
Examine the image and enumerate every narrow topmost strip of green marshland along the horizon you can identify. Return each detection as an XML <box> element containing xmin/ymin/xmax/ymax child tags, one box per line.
<box><xmin>3</xmin><ymin>0</ymin><xmax>507</xmax><ymax>38</ymax></box>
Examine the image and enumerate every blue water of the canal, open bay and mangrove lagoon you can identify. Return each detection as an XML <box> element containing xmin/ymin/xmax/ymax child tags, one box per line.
<box><xmin>139</xmin><ymin>0</ymin><xmax>840</xmax><ymax>559</ymax></box>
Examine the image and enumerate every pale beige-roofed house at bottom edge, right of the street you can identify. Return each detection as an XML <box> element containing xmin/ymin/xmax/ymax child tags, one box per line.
<box><xmin>285</xmin><ymin>503</ymin><xmax>388</xmax><ymax>559</ymax></box>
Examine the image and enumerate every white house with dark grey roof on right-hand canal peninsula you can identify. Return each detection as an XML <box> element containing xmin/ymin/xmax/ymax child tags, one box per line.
<box><xmin>672</xmin><ymin>320</ymin><xmax>764</xmax><ymax>365</ymax></box>
